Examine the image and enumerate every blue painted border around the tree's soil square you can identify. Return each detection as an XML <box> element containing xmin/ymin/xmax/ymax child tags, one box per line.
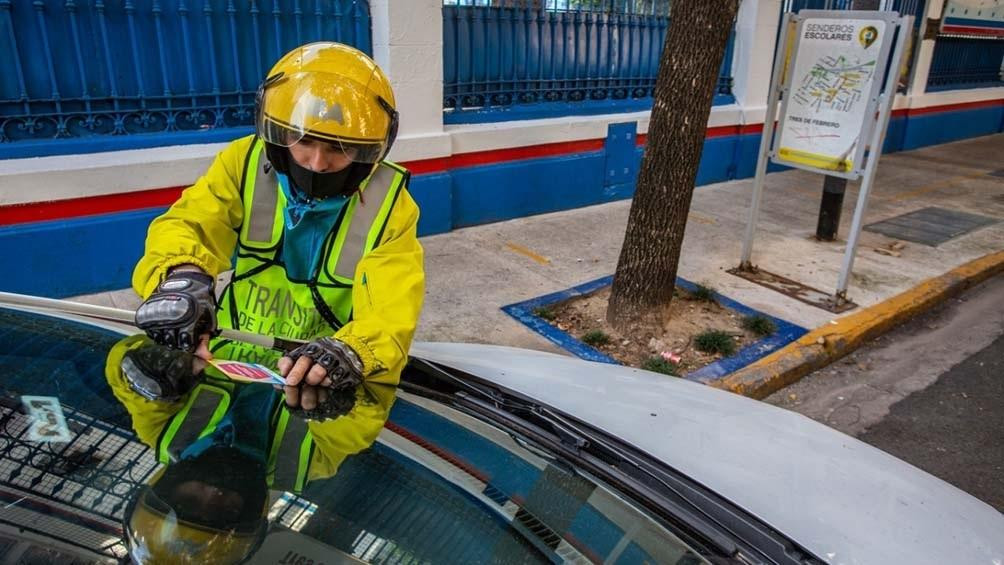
<box><xmin>502</xmin><ymin>275</ymin><xmax>808</xmax><ymax>384</ymax></box>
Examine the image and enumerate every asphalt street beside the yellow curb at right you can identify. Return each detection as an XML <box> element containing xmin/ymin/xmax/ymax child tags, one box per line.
<box><xmin>767</xmin><ymin>275</ymin><xmax>1004</xmax><ymax>512</ymax></box>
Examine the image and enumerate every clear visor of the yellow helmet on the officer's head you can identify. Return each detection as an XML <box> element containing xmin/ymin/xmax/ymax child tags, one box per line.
<box><xmin>256</xmin><ymin>72</ymin><xmax>391</xmax><ymax>163</ymax></box>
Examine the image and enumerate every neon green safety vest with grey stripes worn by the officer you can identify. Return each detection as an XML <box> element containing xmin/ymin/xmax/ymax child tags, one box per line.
<box><xmin>217</xmin><ymin>138</ymin><xmax>408</xmax><ymax>355</ymax></box>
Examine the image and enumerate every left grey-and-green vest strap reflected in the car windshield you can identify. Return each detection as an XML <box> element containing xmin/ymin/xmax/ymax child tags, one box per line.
<box><xmin>157</xmin><ymin>382</ymin><xmax>230</xmax><ymax>465</ymax></box>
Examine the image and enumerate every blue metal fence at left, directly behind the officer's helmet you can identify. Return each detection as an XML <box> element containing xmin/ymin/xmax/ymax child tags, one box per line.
<box><xmin>0</xmin><ymin>0</ymin><xmax>371</xmax><ymax>158</ymax></box>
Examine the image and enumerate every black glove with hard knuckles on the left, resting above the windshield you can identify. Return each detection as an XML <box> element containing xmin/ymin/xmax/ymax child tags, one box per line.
<box><xmin>136</xmin><ymin>271</ymin><xmax>219</xmax><ymax>353</ymax></box>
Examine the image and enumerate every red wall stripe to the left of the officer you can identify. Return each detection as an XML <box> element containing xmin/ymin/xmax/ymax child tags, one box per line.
<box><xmin>0</xmin><ymin>187</ymin><xmax>184</xmax><ymax>226</ymax></box>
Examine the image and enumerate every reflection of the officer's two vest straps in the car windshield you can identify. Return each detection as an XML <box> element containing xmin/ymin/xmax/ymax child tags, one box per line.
<box><xmin>157</xmin><ymin>379</ymin><xmax>314</xmax><ymax>493</ymax></box>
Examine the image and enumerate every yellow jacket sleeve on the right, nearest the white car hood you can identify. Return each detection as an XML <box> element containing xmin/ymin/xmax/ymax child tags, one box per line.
<box><xmin>334</xmin><ymin>188</ymin><xmax>426</xmax><ymax>384</ymax></box>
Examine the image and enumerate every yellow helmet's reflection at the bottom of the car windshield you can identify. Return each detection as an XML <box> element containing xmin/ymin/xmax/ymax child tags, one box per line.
<box><xmin>122</xmin><ymin>470</ymin><xmax>268</xmax><ymax>565</ymax></box>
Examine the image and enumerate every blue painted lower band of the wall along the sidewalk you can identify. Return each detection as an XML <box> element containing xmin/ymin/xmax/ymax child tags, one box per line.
<box><xmin>0</xmin><ymin>105</ymin><xmax>1004</xmax><ymax>297</ymax></box>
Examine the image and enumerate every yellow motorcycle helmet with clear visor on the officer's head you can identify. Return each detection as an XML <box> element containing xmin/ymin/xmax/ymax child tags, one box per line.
<box><xmin>256</xmin><ymin>42</ymin><xmax>398</xmax><ymax>163</ymax></box>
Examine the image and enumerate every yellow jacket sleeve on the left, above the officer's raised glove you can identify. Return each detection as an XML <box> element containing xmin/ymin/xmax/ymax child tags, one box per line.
<box><xmin>133</xmin><ymin>137</ymin><xmax>253</xmax><ymax>298</ymax></box>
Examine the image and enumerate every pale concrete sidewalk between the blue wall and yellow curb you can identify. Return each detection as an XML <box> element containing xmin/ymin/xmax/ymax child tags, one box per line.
<box><xmin>76</xmin><ymin>134</ymin><xmax>1004</xmax><ymax>363</ymax></box>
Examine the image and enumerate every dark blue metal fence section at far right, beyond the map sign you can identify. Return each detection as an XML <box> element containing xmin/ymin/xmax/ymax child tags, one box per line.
<box><xmin>927</xmin><ymin>35</ymin><xmax>1004</xmax><ymax>91</ymax></box>
